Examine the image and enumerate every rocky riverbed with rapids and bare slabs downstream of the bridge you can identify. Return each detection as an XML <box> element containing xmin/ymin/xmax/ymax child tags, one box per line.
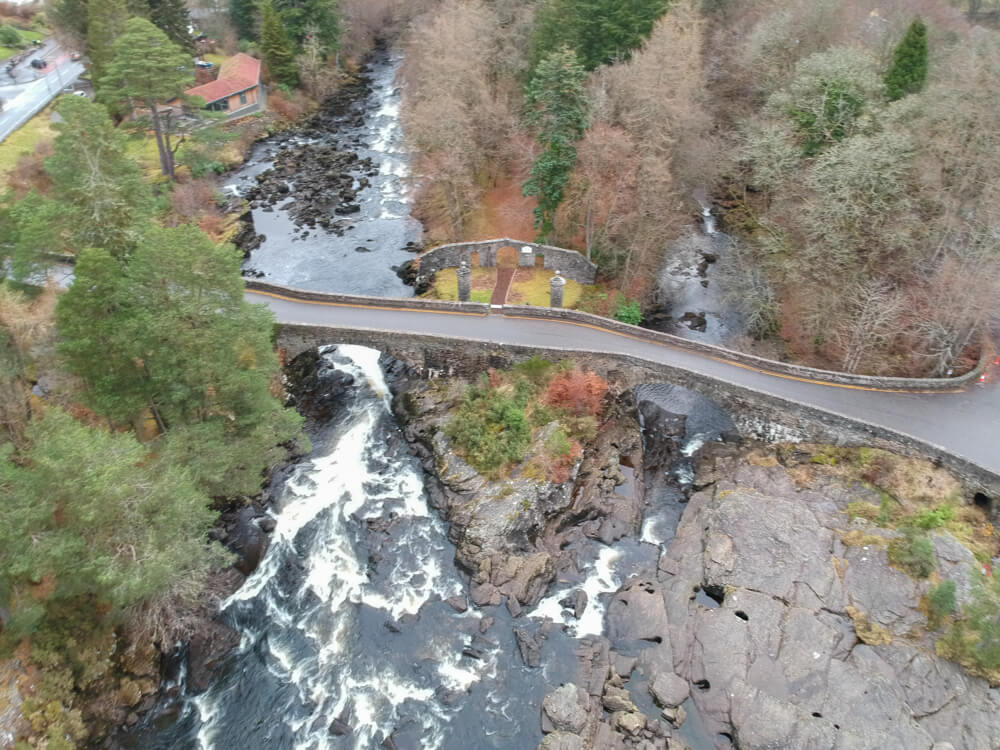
<box><xmin>103</xmin><ymin>347</ymin><xmax>1000</xmax><ymax>750</ymax></box>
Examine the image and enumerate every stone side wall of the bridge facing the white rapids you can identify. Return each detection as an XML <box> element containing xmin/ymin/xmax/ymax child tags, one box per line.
<box><xmin>278</xmin><ymin>324</ymin><xmax>1000</xmax><ymax>520</ymax></box>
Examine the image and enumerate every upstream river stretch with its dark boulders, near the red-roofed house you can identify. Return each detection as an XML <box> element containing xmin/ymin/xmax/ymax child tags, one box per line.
<box><xmin>227</xmin><ymin>49</ymin><xmax>423</xmax><ymax>297</ymax></box>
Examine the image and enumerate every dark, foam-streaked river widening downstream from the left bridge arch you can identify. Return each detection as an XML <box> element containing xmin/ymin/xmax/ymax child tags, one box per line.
<box><xmin>129</xmin><ymin>346</ymin><xmax>588</xmax><ymax>750</ymax></box>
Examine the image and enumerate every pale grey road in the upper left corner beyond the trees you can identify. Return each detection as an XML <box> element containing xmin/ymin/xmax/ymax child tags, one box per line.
<box><xmin>0</xmin><ymin>41</ymin><xmax>83</xmax><ymax>142</ymax></box>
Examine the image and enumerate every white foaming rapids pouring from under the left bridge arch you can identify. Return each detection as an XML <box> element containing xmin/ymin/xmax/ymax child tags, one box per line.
<box><xmin>188</xmin><ymin>346</ymin><xmax>494</xmax><ymax>750</ymax></box>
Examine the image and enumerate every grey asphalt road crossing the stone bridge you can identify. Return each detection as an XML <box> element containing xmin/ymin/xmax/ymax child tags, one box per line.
<box><xmin>246</xmin><ymin>291</ymin><xmax>1000</xmax><ymax>474</ymax></box>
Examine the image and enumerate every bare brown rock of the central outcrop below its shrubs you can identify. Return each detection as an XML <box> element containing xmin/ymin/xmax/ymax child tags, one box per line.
<box><xmin>396</xmin><ymin>384</ymin><xmax>642</xmax><ymax>612</ymax></box>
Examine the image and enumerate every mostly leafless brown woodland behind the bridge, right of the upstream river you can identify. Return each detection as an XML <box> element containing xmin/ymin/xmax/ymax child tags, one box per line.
<box><xmin>404</xmin><ymin>0</ymin><xmax>1000</xmax><ymax>375</ymax></box>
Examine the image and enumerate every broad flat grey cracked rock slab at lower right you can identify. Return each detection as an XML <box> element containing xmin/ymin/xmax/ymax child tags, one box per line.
<box><xmin>653</xmin><ymin>458</ymin><xmax>1000</xmax><ymax>750</ymax></box>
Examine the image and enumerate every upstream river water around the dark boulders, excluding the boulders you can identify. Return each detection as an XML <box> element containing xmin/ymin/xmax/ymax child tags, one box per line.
<box><xmin>227</xmin><ymin>51</ymin><xmax>423</xmax><ymax>297</ymax></box>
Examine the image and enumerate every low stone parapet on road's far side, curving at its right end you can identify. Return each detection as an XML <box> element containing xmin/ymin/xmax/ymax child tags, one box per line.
<box><xmin>503</xmin><ymin>305</ymin><xmax>988</xmax><ymax>391</ymax></box>
